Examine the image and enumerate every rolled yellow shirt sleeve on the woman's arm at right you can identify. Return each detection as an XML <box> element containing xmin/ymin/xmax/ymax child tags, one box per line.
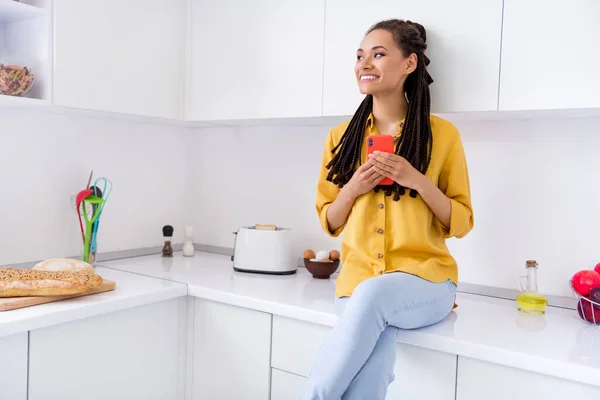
<box><xmin>435</xmin><ymin>136</ymin><xmax>474</xmax><ymax>239</ymax></box>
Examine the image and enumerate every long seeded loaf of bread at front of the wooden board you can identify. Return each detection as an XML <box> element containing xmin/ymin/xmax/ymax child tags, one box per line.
<box><xmin>0</xmin><ymin>268</ymin><xmax>102</xmax><ymax>297</ymax></box>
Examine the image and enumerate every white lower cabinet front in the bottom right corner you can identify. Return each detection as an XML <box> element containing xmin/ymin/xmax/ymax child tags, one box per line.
<box><xmin>456</xmin><ymin>357</ymin><xmax>600</xmax><ymax>400</ymax></box>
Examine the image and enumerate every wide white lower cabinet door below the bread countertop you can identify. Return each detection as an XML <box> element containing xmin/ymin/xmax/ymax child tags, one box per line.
<box><xmin>29</xmin><ymin>299</ymin><xmax>185</xmax><ymax>400</ymax></box>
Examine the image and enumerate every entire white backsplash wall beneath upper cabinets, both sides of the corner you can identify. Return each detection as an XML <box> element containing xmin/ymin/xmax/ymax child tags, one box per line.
<box><xmin>0</xmin><ymin>109</ymin><xmax>600</xmax><ymax>295</ymax></box>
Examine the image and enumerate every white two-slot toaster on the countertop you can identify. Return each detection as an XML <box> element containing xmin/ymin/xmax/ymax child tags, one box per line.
<box><xmin>231</xmin><ymin>225</ymin><xmax>298</xmax><ymax>275</ymax></box>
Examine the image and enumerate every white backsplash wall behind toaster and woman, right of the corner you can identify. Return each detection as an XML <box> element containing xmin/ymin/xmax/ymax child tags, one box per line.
<box><xmin>191</xmin><ymin>115</ymin><xmax>600</xmax><ymax>296</ymax></box>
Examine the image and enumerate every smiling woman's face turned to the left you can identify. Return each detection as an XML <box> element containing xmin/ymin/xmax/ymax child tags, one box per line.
<box><xmin>354</xmin><ymin>29</ymin><xmax>417</xmax><ymax>95</ymax></box>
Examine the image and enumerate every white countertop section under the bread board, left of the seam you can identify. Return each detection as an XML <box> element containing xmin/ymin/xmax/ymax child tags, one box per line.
<box><xmin>0</xmin><ymin>267</ymin><xmax>187</xmax><ymax>337</ymax></box>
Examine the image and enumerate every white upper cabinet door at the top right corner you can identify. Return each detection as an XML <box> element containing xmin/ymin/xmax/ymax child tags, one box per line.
<box><xmin>500</xmin><ymin>0</ymin><xmax>600</xmax><ymax>110</ymax></box>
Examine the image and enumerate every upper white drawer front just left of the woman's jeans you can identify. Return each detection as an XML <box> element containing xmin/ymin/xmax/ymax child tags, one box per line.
<box><xmin>271</xmin><ymin>315</ymin><xmax>331</xmax><ymax>377</ymax></box>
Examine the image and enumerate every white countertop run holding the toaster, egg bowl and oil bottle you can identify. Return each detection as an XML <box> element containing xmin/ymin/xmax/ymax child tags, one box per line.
<box><xmin>101</xmin><ymin>252</ymin><xmax>600</xmax><ymax>386</ymax></box>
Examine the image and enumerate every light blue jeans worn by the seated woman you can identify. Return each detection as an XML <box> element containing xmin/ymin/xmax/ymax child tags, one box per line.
<box><xmin>301</xmin><ymin>272</ymin><xmax>456</xmax><ymax>400</ymax></box>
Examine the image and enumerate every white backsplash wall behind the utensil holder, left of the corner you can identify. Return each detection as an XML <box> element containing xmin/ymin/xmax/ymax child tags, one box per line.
<box><xmin>0</xmin><ymin>109</ymin><xmax>189</xmax><ymax>265</ymax></box>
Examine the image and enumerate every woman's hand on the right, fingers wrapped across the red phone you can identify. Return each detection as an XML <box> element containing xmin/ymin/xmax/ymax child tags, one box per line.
<box><xmin>368</xmin><ymin>151</ymin><xmax>426</xmax><ymax>191</ymax></box>
